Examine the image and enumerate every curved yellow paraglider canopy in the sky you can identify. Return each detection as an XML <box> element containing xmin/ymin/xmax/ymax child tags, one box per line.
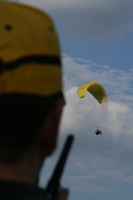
<box><xmin>77</xmin><ymin>82</ymin><xmax>108</xmax><ymax>105</ymax></box>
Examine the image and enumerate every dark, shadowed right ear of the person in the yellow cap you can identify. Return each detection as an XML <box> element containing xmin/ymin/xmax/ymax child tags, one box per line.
<box><xmin>40</xmin><ymin>99</ymin><xmax>64</xmax><ymax>157</ymax></box>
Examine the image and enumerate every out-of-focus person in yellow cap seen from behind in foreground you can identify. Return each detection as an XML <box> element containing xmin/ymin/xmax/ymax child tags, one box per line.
<box><xmin>0</xmin><ymin>1</ymin><xmax>68</xmax><ymax>200</ymax></box>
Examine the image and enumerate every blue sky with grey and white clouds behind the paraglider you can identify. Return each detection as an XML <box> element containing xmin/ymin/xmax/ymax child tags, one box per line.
<box><xmin>4</xmin><ymin>0</ymin><xmax>133</xmax><ymax>200</ymax></box>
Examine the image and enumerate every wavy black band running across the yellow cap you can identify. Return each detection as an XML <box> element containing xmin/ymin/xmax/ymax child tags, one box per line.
<box><xmin>0</xmin><ymin>55</ymin><xmax>61</xmax><ymax>73</ymax></box>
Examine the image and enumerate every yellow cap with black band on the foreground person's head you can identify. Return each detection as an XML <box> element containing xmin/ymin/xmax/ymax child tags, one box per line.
<box><xmin>0</xmin><ymin>2</ymin><xmax>62</xmax><ymax>96</ymax></box>
